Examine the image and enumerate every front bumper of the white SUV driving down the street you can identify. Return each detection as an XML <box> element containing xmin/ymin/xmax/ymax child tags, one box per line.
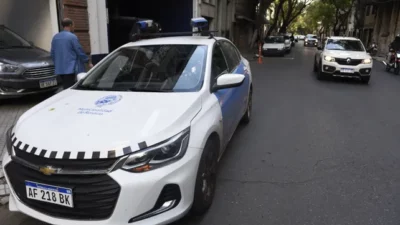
<box><xmin>321</xmin><ymin>61</ymin><xmax>373</xmax><ymax>78</ymax></box>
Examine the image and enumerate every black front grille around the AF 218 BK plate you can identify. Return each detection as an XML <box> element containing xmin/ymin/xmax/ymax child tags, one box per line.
<box><xmin>5</xmin><ymin>161</ymin><xmax>121</xmax><ymax>220</ymax></box>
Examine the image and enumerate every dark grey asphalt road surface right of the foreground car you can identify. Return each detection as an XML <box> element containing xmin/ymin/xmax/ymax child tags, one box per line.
<box><xmin>0</xmin><ymin>42</ymin><xmax>400</xmax><ymax>225</ymax></box>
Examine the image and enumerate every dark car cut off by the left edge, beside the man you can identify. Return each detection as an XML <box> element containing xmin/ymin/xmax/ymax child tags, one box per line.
<box><xmin>0</xmin><ymin>25</ymin><xmax>61</xmax><ymax>99</ymax></box>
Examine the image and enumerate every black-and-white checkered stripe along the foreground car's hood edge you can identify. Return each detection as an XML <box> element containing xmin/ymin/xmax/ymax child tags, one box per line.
<box><xmin>11</xmin><ymin>133</ymin><xmax>147</xmax><ymax>159</ymax></box>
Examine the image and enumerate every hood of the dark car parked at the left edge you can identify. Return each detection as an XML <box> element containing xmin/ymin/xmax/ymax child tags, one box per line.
<box><xmin>0</xmin><ymin>48</ymin><xmax>53</xmax><ymax>68</ymax></box>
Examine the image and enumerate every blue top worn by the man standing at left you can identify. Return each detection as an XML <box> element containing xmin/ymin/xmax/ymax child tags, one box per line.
<box><xmin>51</xmin><ymin>31</ymin><xmax>89</xmax><ymax>75</ymax></box>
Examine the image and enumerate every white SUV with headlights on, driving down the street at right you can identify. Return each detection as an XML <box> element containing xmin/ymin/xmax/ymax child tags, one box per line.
<box><xmin>314</xmin><ymin>37</ymin><xmax>373</xmax><ymax>84</ymax></box>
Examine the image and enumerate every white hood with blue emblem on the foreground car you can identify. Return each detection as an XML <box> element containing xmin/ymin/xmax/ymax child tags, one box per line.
<box><xmin>14</xmin><ymin>89</ymin><xmax>201</xmax><ymax>153</ymax></box>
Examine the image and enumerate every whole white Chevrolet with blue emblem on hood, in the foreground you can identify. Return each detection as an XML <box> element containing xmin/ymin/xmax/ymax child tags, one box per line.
<box><xmin>3</xmin><ymin>18</ymin><xmax>252</xmax><ymax>225</ymax></box>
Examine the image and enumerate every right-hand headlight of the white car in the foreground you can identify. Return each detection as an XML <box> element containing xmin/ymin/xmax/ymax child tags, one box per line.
<box><xmin>122</xmin><ymin>128</ymin><xmax>190</xmax><ymax>173</ymax></box>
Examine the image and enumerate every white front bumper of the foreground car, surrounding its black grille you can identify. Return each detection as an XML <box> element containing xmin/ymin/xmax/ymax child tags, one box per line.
<box><xmin>3</xmin><ymin>147</ymin><xmax>202</xmax><ymax>225</ymax></box>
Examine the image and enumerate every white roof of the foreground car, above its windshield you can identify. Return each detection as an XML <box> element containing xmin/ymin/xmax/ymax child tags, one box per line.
<box><xmin>123</xmin><ymin>36</ymin><xmax>222</xmax><ymax>47</ymax></box>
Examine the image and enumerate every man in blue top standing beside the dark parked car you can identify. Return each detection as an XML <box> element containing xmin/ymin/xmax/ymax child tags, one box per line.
<box><xmin>51</xmin><ymin>18</ymin><xmax>93</xmax><ymax>90</ymax></box>
